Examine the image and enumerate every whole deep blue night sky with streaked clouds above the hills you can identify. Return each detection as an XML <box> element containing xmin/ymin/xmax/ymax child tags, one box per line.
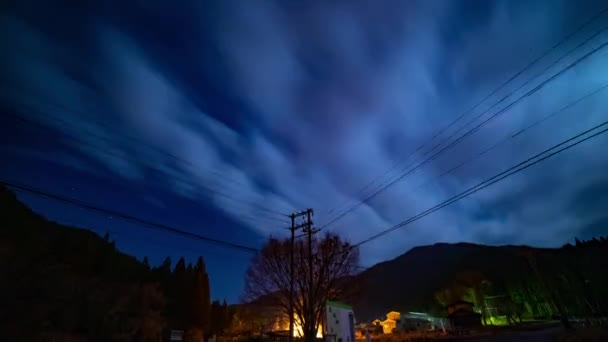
<box><xmin>0</xmin><ymin>0</ymin><xmax>608</xmax><ymax>302</ymax></box>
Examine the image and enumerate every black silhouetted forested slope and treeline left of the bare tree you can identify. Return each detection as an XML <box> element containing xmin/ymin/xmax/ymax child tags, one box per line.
<box><xmin>0</xmin><ymin>188</ymin><xmax>231</xmax><ymax>341</ymax></box>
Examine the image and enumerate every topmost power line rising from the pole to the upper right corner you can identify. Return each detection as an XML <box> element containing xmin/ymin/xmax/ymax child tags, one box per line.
<box><xmin>320</xmin><ymin>7</ymin><xmax>608</xmax><ymax>219</ymax></box>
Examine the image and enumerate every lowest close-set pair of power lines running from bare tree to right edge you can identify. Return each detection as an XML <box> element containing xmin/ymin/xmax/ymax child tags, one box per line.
<box><xmin>353</xmin><ymin>116</ymin><xmax>608</xmax><ymax>248</ymax></box>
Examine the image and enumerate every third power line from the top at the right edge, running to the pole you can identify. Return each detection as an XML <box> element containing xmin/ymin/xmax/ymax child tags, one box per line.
<box><xmin>321</xmin><ymin>32</ymin><xmax>608</xmax><ymax>228</ymax></box>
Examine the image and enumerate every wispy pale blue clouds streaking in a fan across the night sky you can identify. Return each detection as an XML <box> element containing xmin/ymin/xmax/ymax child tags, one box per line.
<box><xmin>0</xmin><ymin>1</ymin><xmax>608</xmax><ymax>263</ymax></box>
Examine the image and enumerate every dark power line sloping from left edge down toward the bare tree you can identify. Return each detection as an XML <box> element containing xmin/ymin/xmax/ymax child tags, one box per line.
<box><xmin>0</xmin><ymin>180</ymin><xmax>258</xmax><ymax>253</ymax></box>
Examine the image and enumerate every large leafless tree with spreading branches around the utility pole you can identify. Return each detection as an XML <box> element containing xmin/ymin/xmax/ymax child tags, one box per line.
<box><xmin>245</xmin><ymin>234</ymin><xmax>359</xmax><ymax>341</ymax></box>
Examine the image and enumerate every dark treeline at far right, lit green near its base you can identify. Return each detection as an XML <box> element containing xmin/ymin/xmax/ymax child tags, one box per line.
<box><xmin>435</xmin><ymin>237</ymin><xmax>608</xmax><ymax>324</ymax></box>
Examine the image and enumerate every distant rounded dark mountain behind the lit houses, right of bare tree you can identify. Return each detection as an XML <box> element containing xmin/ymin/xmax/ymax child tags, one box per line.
<box><xmin>355</xmin><ymin>243</ymin><xmax>530</xmax><ymax>319</ymax></box>
